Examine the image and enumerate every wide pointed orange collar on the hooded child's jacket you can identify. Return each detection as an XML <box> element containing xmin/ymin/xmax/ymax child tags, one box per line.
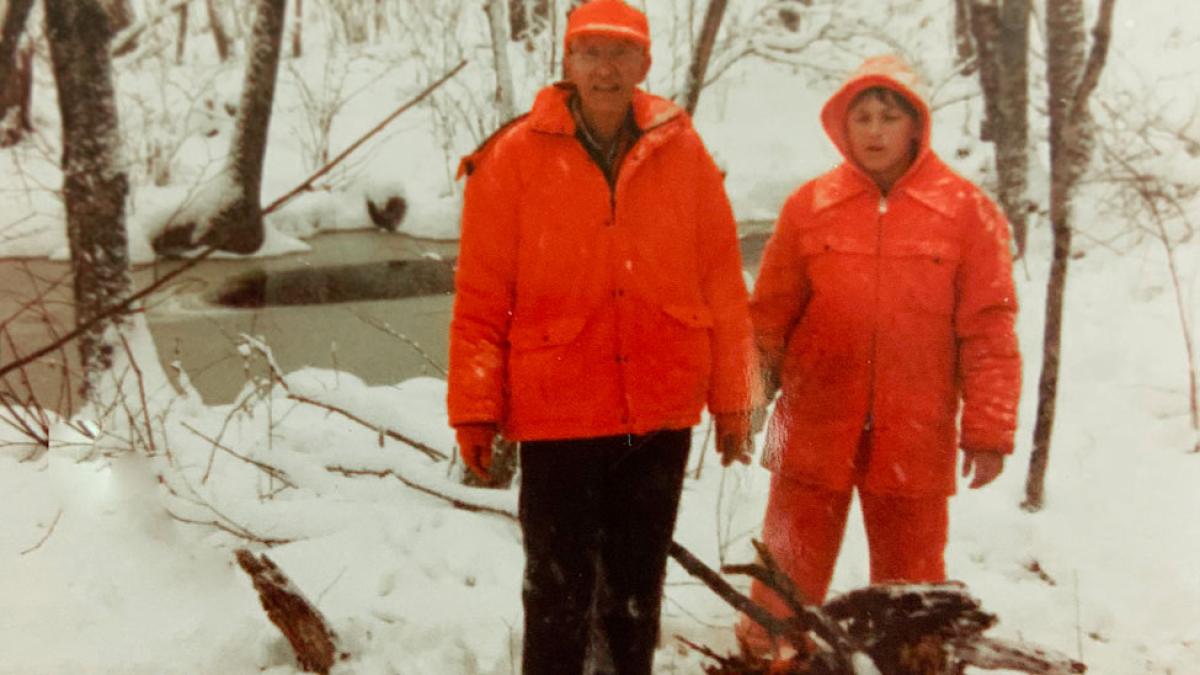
<box><xmin>812</xmin><ymin>151</ymin><xmax>958</xmax><ymax>217</ymax></box>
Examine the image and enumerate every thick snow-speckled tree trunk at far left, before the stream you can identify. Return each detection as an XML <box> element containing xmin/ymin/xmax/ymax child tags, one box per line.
<box><xmin>46</xmin><ymin>0</ymin><xmax>130</xmax><ymax>400</ymax></box>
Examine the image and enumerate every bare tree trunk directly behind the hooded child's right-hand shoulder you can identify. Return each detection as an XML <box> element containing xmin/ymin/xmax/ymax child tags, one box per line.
<box><xmin>959</xmin><ymin>0</ymin><xmax>1030</xmax><ymax>255</ymax></box>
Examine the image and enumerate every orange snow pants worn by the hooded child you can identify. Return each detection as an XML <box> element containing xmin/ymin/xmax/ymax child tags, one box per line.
<box><xmin>737</xmin><ymin>473</ymin><xmax>949</xmax><ymax>653</ymax></box>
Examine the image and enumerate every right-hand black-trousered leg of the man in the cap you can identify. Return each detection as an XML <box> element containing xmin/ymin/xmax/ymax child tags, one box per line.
<box><xmin>596</xmin><ymin>429</ymin><xmax>691</xmax><ymax>675</ymax></box>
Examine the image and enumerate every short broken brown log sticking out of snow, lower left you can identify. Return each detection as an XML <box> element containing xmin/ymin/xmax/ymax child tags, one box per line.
<box><xmin>234</xmin><ymin>549</ymin><xmax>337</xmax><ymax>673</ymax></box>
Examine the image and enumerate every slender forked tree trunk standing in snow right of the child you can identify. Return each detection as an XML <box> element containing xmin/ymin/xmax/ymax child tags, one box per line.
<box><xmin>1022</xmin><ymin>0</ymin><xmax>1116</xmax><ymax>510</ymax></box>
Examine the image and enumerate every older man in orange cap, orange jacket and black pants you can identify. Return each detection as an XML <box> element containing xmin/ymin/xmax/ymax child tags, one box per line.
<box><xmin>449</xmin><ymin>0</ymin><xmax>756</xmax><ymax>675</ymax></box>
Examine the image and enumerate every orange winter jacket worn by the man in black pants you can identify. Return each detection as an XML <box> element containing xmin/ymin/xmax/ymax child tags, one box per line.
<box><xmin>449</xmin><ymin>85</ymin><xmax>754</xmax><ymax>441</ymax></box>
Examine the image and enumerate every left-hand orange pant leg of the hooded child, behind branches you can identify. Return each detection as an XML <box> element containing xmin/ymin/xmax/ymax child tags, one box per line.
<box><xmin>737</xmin><ymin>473</ymin><xmax>851</xmax><ymax>653</ymax></box>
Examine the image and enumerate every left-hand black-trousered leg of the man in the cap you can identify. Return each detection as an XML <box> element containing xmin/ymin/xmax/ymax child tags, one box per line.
<box><xmin>520</xmin><ymin>441</ymin><xmax>602</xmax><ymax>675</ymax></box>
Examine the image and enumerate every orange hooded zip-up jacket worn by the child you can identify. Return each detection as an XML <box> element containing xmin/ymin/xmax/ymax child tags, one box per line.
<box><xmin>751</xmin><ymin>58</ymin><xmax>1021</xmax><ymax>495</ymax></box>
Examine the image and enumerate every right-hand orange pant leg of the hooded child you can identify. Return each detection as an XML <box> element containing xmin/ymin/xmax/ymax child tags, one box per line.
<box><xmin>859</xmin><ymin>492</ymin><xmax>949</xmax><ymax>584</ymax></box>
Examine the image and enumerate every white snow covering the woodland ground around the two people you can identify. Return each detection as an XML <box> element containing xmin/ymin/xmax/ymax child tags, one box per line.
<box><xmin>0</xmin><ymin>0</ymin><xmax>1200</xmax><ymax>675</ymax></box>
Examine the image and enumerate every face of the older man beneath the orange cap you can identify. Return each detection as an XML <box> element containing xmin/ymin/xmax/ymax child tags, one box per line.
<box><xmin>563</xmin><ymin>35</ymin><xmax>650</xmax><ymax>123</ymax></box>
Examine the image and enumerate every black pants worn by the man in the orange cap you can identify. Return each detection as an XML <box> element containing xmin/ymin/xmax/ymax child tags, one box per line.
<box><xmin>520</xmin><ymin>430</ymin><xmax>691</xmax><ymax>675</ymax></box>
